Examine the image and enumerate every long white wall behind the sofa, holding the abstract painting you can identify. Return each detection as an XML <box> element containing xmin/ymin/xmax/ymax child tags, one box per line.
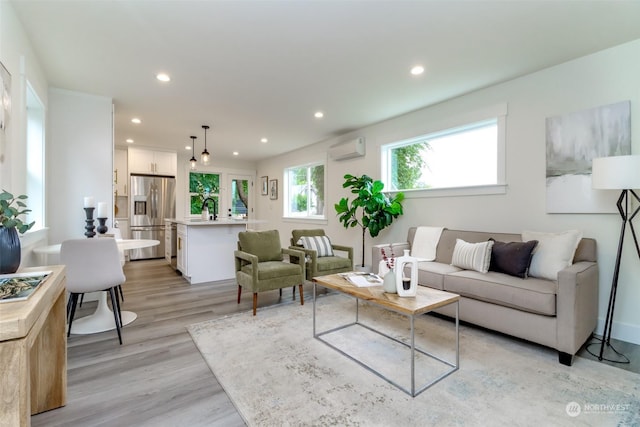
<box><xmin>257</xmin><ymin>40</ymin><xmax>640</xmax><ymax>344</ymax></box>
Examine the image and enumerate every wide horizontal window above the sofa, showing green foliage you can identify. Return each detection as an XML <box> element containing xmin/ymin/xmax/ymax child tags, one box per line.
<box><xmin>381</xmin><ymin>105</ymin><xmax>505</xmax><ymax>194</ymax></box>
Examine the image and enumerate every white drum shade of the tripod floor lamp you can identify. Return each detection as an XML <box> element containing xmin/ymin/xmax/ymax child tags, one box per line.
<box><xmin>591</xmin><ymin>156</ymin><xmax>640</xmax><ymax>190</ymax></box>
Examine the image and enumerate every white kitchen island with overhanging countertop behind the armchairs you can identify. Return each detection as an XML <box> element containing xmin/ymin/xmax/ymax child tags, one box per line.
<box><xmin>165</xmin><ymin>218</ymin><xmax>252</xmax><ymax>285</ymax></box>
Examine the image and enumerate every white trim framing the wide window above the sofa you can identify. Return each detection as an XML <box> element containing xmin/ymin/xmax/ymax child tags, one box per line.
<box><xmin>380</xmin><ymin>103</ymin><xmax>508</xmax><ymax>199</ymax></box>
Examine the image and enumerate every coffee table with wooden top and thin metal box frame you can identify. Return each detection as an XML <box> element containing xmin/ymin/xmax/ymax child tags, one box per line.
<box><xmin>313</xmin><ymin>274</ymin><xmax>460</xmax><ymax>397</ymax></box>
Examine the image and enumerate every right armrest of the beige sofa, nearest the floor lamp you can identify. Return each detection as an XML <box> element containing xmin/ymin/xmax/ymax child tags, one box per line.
<box><xmin>556</xmin><ymin>261</ymin><xmax>598</xmax><ymax>355</ymax></box>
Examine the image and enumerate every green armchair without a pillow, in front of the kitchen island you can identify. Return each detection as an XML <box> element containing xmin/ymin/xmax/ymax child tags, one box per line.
<box><xmin>233</xmin><ymin>230</ymin><xmax>305</xmax><ymax>316</ymax></box>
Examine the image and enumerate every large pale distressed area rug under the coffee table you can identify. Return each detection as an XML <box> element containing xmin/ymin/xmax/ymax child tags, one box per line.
<box><xmin>188</xmin><ymin>294</ymin><xmax>640</xmax><ymax>426</ymax></box>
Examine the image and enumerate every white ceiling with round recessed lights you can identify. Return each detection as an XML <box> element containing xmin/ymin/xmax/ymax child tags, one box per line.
<box><xmin>12</xmin><ymin>0</ymin><xmax>640</xmax><ymax>162</ymax></box>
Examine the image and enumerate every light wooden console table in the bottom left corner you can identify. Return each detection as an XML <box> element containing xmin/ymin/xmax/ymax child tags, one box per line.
<box><xmin>0</xmin><ymin>265</ymin><xmax>67</xmax><ymax>427</ymax></box>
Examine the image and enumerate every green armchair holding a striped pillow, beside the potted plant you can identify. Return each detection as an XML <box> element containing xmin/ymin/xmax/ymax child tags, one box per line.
<box><xmin>289</xmin><ymin>228</ymin><xmax>353</xmax><ymax>280</ymax></box>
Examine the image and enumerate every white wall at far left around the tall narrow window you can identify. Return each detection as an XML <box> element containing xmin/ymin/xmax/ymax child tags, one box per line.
<box><xmin>0</xmin><ymin>1</ymin><xmax>47</xmax><ymax>267</ymax></box>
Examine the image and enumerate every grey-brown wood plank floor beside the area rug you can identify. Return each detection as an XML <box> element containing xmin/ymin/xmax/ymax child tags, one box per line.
<box><xmin>31</xmin><ymin>260</ymin><xmax>640</xmax><ymax>427</ymax></box>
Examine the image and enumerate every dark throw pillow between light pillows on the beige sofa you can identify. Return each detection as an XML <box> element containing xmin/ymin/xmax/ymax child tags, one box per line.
<box><xmin>489</xmin><ymin>238</ymin><xmax>538</xmax><ymax>279</ymax></box>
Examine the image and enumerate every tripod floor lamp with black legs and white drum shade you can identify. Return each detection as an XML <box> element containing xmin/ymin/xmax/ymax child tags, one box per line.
<box><xmin>591</xmin><ymin>156</ymin><xmax>640</xmax><ymax>361</ymax></box>
